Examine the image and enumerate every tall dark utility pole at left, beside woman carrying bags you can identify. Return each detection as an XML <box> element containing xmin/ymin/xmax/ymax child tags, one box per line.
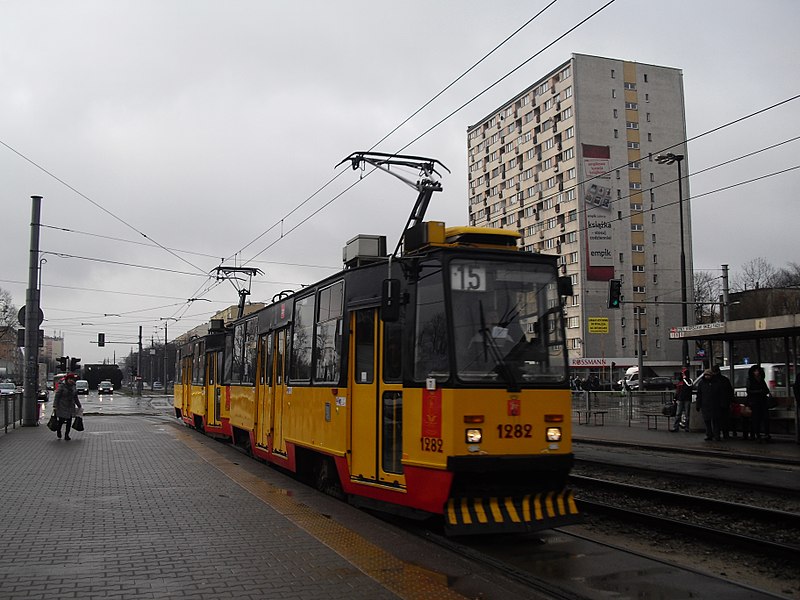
<box><xmin>22</xmin><ymin>196</ymin><xmax>42</xmax><ymax>427</ymax></box>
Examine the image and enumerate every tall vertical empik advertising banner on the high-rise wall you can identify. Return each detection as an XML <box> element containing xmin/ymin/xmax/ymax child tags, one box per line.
<box><xmin>581</xmin><ymin>144</ymin><xmax>614</xmax><ymax>281</ymax></box>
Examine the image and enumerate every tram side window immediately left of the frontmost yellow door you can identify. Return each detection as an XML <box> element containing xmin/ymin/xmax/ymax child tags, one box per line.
<box><xmin>314</xmin><ymin>281</ymin><xmax>344</xmax><ymax>383</ymax></box>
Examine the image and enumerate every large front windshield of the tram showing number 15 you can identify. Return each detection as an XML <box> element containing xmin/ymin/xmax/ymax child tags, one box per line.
<box><xmin>448</xmin><ymin>259</ymin><xmax>566</xmax><ymax>387</ymax></box>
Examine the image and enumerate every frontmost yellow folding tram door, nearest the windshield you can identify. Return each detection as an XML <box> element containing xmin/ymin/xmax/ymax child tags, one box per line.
<box><xmin>349</xmin><ymin>309</ymin><xmax>405</xmax><ymax>487</ymax></box>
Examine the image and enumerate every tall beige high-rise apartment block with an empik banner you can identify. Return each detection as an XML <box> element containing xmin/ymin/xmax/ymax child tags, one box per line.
<box><xmin>467</xmin><ymin>54</ymin><xmax>694</xmax><ymax>381</ymax></box>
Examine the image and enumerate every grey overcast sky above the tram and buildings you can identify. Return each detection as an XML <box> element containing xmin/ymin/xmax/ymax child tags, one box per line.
<box><xmin>0</xmin><ymin>0</ymin><xmax>800</xmax><ymax>363</ymax></box>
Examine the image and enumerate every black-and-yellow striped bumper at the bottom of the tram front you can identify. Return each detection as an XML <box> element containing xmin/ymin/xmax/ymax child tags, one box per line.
<box><xmin>444</xmin><ymin>490</ymin><xmax>583</xmax><ymax>535</ymax></box>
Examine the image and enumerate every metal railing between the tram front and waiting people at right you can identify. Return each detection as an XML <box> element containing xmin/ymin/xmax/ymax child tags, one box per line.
<box><xmin>572</xmin><ymin>390</ymin><xmax>675</xmax><ymax>426</ymax></box>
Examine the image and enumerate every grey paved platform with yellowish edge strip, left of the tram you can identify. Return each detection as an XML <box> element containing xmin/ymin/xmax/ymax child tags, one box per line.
<box><xmin>0</xmin><ymin>416</ymin><xmax>476</xmax><ymax>600</ymax></box>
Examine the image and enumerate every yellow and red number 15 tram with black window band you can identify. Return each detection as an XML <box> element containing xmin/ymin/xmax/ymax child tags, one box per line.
<box><xmin>174</xmin><ymin>153</ymin><xmax>580</xmax><ymax>535</ymax></box>
